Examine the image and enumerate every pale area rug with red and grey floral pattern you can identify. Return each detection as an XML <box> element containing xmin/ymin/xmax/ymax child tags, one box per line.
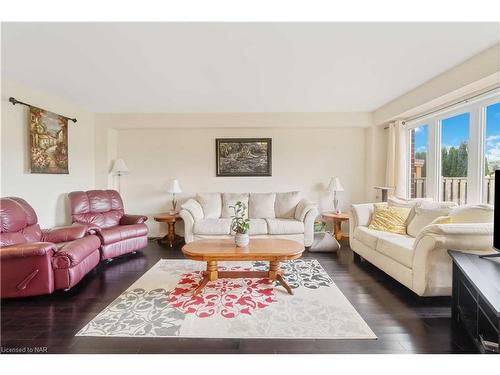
<box><xmin>77</xmin><ymin>259</ymin><xmax>376</xmax><ymax>339</ymax></box>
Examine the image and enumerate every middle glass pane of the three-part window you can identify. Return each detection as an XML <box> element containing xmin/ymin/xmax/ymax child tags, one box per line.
<box><xmin>440</xmin><ymin>113</ymin><xmax>470</xmax><ymax>204</ymax></box>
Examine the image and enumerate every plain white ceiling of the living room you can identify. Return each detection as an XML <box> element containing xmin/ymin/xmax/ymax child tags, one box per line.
<box><xmin>2</xmin><ymin>23</ymin><xmax>500</xmax><ymax>112</ymax></box>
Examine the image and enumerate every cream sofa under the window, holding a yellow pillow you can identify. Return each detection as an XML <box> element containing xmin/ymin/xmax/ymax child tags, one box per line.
<box><xmin>349</xmin><ymin>203</ymin><xmax>493</xmax><ymax>296</ymax></box>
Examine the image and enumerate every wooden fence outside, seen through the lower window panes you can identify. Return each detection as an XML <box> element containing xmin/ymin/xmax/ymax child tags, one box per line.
<box><xmin>412</xmin><ymin>176</ymin><xmax>495</xmax><ymax>204</ymax></box>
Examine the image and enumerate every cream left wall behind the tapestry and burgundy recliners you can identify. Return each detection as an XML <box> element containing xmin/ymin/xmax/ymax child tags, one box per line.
<box><xmin>1</xmin><ymin>80</ymin><xmax>95</xmax><ymax>228</ymax></box>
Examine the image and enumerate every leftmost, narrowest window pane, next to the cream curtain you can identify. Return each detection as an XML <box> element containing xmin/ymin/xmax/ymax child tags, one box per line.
<box><xmin>410</xmin><ymin>125</ymin><xmax>429</xmax><ymax>198</ymax></box>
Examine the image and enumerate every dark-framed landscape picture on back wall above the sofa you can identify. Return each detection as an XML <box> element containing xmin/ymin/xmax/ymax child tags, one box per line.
<box><xmin>215</xmin><ymin>138</ymin><xmax>272</xmax><ymax>177</ymax></box>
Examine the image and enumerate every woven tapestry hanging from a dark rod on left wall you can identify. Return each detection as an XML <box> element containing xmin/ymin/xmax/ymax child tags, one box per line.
<box><xmin>29</xmin><ymin>107</ymin><xmax>69</xmax><ymax>174</ymax></box>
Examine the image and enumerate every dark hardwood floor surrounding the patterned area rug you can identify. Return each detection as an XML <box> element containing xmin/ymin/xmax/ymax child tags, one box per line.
<box><xmin>0</xmin><ymin>241</ymin><xmax>475</xmax><ymax>353</ymax></box>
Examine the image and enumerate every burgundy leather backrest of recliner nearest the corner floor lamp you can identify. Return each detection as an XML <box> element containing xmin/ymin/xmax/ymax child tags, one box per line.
<box><xmin>68</xmin><ymin>190</ymin><xmax>124</xmax><ymax>228</ymax></box>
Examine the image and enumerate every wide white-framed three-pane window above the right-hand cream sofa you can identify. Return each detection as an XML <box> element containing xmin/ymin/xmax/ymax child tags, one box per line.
<box><xmin>406</xmin><ymin>92</ymin><xmax>500</xmax><ymax>204</ymax></box>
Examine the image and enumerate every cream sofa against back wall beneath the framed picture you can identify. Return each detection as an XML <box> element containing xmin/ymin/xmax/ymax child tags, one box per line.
<box><xmin>179</xmin><ymin>192</ymin><xmax>318</xmax><ymax>247</ymax></box>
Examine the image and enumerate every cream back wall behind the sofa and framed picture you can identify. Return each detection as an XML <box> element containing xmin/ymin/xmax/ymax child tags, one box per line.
<box><xmin>96</xmin><ymin>114</ymin><xmax>372</xmax><ymax>235</ymax></box>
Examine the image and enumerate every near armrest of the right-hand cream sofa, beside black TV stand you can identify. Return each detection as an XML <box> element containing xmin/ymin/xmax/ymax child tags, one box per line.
<box><xmin>412</xmin><ymin>223</ymin><xmax>494</xmax><ymax>295</ymax></box>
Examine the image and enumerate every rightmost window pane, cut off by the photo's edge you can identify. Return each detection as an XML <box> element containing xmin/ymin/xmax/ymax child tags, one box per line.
<box><xmin>483</xmin><ymin>103</ymin><xmax>500</xmax><ymax>204</ymax></box>
